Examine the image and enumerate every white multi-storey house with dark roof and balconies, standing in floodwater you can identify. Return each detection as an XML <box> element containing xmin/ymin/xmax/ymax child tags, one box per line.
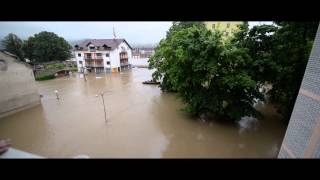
<box><xmin>74</xmin><ymin>39</ymin><xmax>132</xmax><ymax>73</ymax></box>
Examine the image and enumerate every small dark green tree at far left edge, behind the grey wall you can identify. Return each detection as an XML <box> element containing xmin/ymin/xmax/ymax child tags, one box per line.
<box><xmin>1</xmin><ymin>33</ymin><xmax>24</xmax><ymax>61</ymax></box>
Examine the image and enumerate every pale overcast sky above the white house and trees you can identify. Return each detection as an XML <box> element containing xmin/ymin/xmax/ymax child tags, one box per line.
<box><xmin>0</xmin><ymin>21</ymin><xmax>270</xmax><ymax>44</ymax></box>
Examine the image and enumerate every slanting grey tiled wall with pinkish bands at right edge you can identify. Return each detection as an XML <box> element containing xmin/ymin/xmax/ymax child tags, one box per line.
<box><xmin>278</xmin><ymin>23</ymin><xmax>320</xmax><ymax>158</ymax></box>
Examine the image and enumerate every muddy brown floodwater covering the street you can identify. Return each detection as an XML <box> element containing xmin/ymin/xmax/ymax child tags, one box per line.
<box><xmin>0</xmin><ymin>68</ymin><xmax>286</xmax><ymax>158</ymax></box>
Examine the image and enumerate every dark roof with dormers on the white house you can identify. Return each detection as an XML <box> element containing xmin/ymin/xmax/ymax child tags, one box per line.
<box><xmin>75</xmin><ymin>39</ymin><xmax>132</xmax><ymax>50</ymax></box>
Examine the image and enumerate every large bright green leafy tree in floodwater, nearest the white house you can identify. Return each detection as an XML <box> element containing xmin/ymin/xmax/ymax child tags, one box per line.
<box><xmin>149</xmin><ymin>22</ymin><xmax>263</xmax><ymax>120</ymax></box>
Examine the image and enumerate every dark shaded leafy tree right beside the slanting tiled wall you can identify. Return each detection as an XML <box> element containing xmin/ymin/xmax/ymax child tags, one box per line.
<box><xmin>232</xmin><ymin>22</ymin><xmax>318</xmax><ymax>121</ymax></box>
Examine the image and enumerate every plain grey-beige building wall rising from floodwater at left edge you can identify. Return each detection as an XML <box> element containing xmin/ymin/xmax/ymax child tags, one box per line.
<box><xmin>0</xmin><ymin>52</ymin><xmax>40</xmax><ymax>118</ymax></box>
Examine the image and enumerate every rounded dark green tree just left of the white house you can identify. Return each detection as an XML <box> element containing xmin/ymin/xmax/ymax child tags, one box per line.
<box><xmin>23</xmin><ymin>31</ymin><xmax>72</xmax><ymax>62</ymax></box>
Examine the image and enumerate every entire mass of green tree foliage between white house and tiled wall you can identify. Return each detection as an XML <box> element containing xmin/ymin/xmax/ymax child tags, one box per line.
<box><xmin>149</xmin><ymin>22</ymin><xmax>318</xmax><ymax>121</ymax></box>
